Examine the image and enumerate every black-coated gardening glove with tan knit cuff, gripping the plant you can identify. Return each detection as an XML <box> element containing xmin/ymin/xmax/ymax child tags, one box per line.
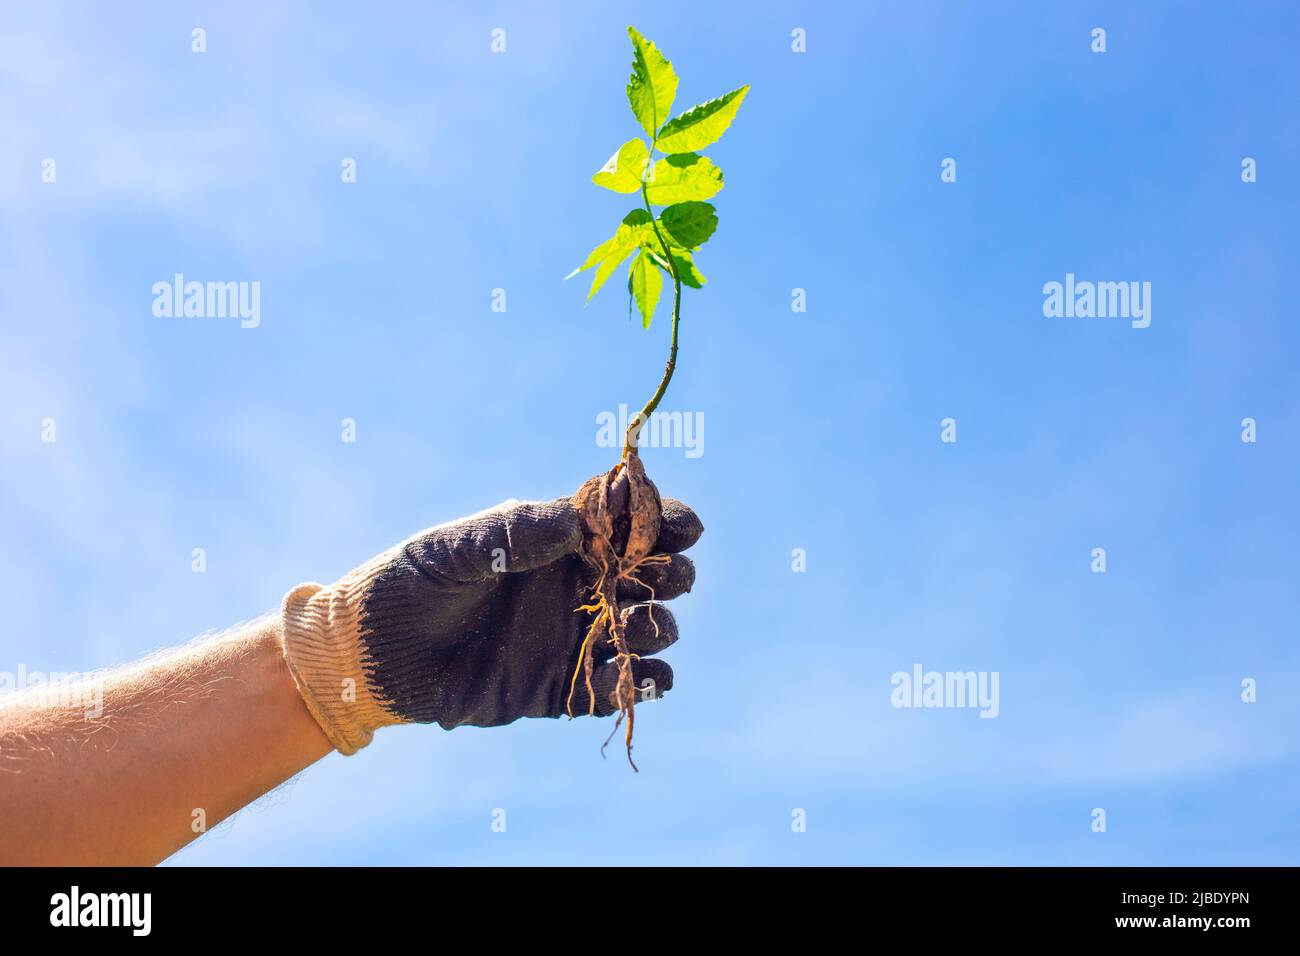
<box><xmin>274</xmin><ymin>498</ymin><xmax>703</xmax><ymax>754</ymax></box>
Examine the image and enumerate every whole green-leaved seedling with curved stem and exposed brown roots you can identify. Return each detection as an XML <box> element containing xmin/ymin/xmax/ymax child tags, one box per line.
<box><xmin>566</xmin><ymin>26</ymin><xmax>749</xmax><ymax>770</ymax></box>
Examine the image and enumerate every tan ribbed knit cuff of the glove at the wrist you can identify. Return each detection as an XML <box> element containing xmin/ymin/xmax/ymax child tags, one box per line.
<box><xmin>281</xmin><ymin>572</ymin><xmax>400</xmax><ymax>754</ymax></box>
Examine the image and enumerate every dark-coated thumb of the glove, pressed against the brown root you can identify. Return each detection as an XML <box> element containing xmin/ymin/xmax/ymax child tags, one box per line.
<box><xmin>406</xmin><ymin>498</ymin><xmax>582</xmax><ymax>583</ymax></box>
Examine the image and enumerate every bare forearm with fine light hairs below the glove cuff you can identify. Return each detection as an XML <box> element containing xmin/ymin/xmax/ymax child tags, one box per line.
<box><xmin>0</xmin><ymin>618</ymin><xmax>332</xmax><ymax>865</ymax></box>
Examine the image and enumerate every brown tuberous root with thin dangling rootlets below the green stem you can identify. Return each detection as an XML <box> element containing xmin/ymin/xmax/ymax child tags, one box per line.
<box><xmin>566</xmin><ymin>449</ymin><xmax>667</xmax><ymax>770</ymax></box>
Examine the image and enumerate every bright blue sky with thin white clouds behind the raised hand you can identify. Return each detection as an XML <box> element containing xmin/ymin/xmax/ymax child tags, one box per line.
<box><xmin>0</xmin><ymin>3</ymin><xmax>1300</xmax><ymax>864</ymax></box>
